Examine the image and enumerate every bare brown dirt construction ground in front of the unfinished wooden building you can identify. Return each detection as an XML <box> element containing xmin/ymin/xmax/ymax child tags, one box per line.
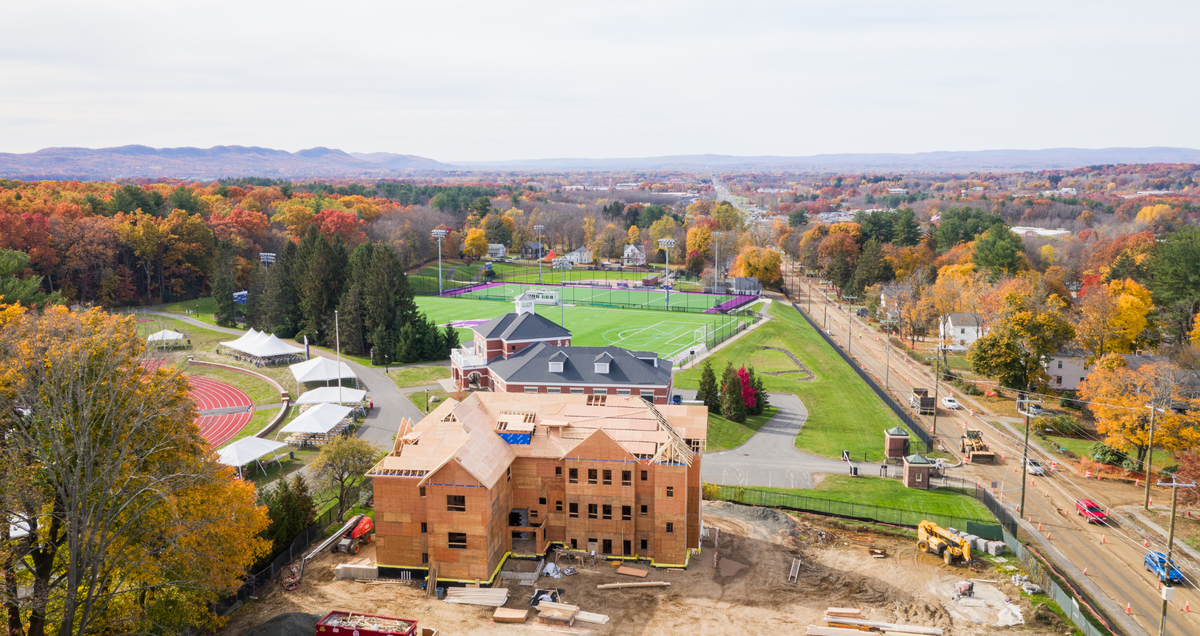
<box><xmin>221</xmin><ymin>502</ymin><xmax>1072</xmax><ymax>636</ymax></box>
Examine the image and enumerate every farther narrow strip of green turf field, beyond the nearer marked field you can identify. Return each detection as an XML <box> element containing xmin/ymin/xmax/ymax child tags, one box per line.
<box><xmin>448</xmin><ymin>281</ymin><xmax>734</xmax><ymax>311</ymax></box>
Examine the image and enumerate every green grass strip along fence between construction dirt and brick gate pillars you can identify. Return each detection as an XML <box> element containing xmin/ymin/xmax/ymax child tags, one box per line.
<box><xmin>755</xmin><ymin>475</ymin><xmax>996</xmax><ymax>523</ymax></box>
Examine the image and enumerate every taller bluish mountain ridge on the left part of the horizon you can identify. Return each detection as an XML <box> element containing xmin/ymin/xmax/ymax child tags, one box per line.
<box><xmin>0</xmin><ymin>145</ymin><xmax>454</xmax><ymax>181</ymax></box>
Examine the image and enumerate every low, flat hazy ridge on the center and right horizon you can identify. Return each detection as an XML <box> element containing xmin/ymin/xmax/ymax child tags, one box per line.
<box><xmin>452</xmin><ymin>148</ymin><xmax>1200</xmax><ymax>172</ymax></box>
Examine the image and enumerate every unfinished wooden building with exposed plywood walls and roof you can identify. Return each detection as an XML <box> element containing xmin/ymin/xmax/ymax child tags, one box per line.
<box><xmin>367</xmin><ymin>392</ymin><xmax>708</xmax><ymax>581</ymax></box>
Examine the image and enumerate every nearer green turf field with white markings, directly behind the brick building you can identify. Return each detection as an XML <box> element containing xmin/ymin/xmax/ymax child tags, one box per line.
<box><xmin>416</xmin><ymin>296</ymin><xmax>746</xmax><ymax>358</ymax></box>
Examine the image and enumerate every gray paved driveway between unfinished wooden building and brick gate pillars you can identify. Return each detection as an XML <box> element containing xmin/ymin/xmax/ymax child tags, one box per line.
<box><xmin>677</xmin><ymin>390</ymin><xmax>880</xmax><ymax>488</ymax></box>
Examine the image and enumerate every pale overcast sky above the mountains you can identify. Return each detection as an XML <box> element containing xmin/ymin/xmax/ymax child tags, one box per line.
<box><xmin>0</xmin><ymin>0</ymin><xmax>1200</xmax><ymax>161</ymax></box>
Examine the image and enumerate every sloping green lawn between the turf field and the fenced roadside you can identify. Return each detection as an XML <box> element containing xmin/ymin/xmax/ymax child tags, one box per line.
<box><xmin>676</xmin><ymin>302</ymin><xmax>901</xmax><ymax>462</ymax></box>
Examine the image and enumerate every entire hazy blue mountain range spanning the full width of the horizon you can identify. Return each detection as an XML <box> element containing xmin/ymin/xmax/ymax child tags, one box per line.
<box><xmin>0</xmin><ymin>145</ymin><xmax>1200</xmax><ymax>175</ymax></box>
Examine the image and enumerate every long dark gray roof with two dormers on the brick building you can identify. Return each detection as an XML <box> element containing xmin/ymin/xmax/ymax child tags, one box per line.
<box><xmin>488</xmin><ymin>343</ymin><xmax>671</xmax><ymax>386</ymax></box>
